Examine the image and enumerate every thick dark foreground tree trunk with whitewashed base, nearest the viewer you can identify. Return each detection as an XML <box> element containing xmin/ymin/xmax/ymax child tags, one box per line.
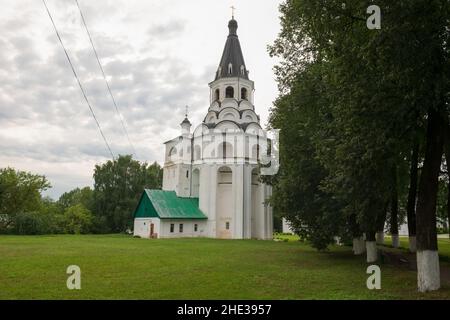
<box><xmin>416</xmin><ymin>110</ymin><xmax>443</xmax><ymax>292</ymax></box>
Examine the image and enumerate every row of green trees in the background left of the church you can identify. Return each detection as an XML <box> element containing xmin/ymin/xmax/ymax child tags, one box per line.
<box><xmin>0</xmin><ymin>156</ymin><xmax>162</xmax><ymax>234</ymax></box>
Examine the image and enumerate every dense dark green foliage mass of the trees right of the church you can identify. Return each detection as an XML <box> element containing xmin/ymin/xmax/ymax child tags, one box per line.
<box><xmin>269</xmin><ymin>0</ymin><xmax>450</xmax><ymax>249</ymax></box>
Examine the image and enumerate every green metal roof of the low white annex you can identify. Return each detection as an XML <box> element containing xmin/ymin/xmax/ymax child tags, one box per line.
<box><xmin>134</xmin><ymin>189</ymin><xmax>208</xmax><ymax>219</ymax></box>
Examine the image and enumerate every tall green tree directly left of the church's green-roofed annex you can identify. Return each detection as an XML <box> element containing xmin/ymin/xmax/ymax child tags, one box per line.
<box><xmin>93</xmin><ymin>156</ymin><xmax>162</xmax><ymax>232</ymax></box>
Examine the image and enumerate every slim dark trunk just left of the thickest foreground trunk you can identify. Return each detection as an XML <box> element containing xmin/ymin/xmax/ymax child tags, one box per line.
<box><xmin>406</xmin><ymin>142</ymin><xmax>419</xmax><ymax>252</ymax></box>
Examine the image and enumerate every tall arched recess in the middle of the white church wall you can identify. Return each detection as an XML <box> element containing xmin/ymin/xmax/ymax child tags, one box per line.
<box><xmin>216</xmin><ymin>167</ymin><xmax>234</xmax><ymax>239</ymax></box>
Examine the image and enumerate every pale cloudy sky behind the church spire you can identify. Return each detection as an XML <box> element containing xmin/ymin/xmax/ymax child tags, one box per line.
<box><xmin>0</xmin><ymin>0</ymin><xmax>281</xmax><ymax>198</ymax></box>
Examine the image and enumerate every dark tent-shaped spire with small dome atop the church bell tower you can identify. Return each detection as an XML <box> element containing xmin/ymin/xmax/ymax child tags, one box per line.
<box><xmin>215</xmin><ymin>18</ymin><xmax>248</xmax><ymax>80</ymax></box>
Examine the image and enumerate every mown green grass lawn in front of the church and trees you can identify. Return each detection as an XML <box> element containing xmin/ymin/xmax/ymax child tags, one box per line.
<box><xmin>0</xmin><ymin>235</ymin><xmax>450</xmax><ymax>299</ymax></box>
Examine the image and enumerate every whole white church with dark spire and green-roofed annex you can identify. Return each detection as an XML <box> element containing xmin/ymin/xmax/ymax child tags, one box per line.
<box><xmin>134</xmin><ymin>17</ymin><xmax>273</xmax><ymax>239</ymax></box>
